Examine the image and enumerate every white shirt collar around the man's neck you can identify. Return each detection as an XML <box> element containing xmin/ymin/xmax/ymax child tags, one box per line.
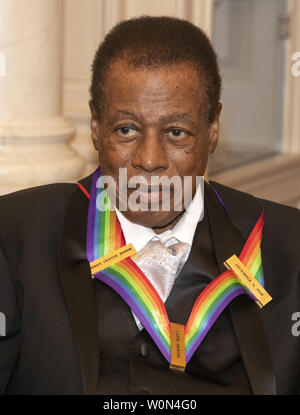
<box><xmin>116</xmin><ymin>180</ymin><xmax>204</xmax><ymax>252</ymax></box>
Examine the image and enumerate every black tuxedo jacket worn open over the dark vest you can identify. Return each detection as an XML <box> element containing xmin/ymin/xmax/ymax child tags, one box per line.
<box><xmin>0</xmin><ymin>177</ymin><xmax>300</xmax><ymax>394</ymax></box>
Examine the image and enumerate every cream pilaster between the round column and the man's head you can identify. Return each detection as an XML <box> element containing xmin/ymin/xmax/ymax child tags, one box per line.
<box><xmin>64</xmin><ymin>0</ymin><xmax>123</xmax><ymax>176</ymax></box>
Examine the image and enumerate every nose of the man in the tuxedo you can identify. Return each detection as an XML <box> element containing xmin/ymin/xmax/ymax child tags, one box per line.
<box><xmin>132</xmin><ymin>131</ymin><xmax>169</xmax><ymax>172</ymax></box>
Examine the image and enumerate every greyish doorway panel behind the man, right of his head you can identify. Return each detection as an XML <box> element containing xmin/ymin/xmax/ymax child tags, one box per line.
<box><xmin>210</xmin><ymin>0</ymin><xmax>289</xmax><ymax>174</ymax></box>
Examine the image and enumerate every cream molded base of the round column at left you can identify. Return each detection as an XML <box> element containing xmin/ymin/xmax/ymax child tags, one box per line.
<box><xmin>0</xmin><ymin>117</ymin><xmax>79</xmax><ymax>194</ymax></box>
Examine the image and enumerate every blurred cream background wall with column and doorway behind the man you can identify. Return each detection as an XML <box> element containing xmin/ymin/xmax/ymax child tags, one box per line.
<box><xmin>0</xmin><ymin>0</ymin><xmax>300</xmax><ymax>208</ymax></box>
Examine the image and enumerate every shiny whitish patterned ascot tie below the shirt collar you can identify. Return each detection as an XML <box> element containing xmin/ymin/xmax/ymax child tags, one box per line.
<box><xmin>133</xmin><ymin>238</ymin><xmax>191</xmax><ymax>329</ymax></box>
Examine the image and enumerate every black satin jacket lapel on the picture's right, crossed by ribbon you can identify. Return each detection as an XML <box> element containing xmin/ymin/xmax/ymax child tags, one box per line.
<box><xmin>205</xmin><ymin>183</ymin><xmax>275</xmax><ymax>395</ymax></box>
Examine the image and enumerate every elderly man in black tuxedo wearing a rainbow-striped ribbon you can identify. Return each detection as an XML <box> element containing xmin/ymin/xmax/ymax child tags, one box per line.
<box><xmin>0</xmin><ymin>17</ymin><xmax>300</xmax><ymax>394</ymax></box>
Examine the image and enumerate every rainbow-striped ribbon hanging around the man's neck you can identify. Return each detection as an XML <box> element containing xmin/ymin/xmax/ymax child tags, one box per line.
<box><xmin>80</xmin><ymin>168</ymin><xmax>264</xmax><ymax>364</ymax></box>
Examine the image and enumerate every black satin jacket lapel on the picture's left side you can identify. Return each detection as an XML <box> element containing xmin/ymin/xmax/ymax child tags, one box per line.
<box><xmin>58</xmin><ymin>177</ymin><xmax>99</xmax><ymax>394</ymax></box>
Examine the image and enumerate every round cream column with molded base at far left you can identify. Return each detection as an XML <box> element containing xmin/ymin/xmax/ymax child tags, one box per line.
<box><xmin>0</xmin><ymin>0</ymin><xmax>84</xmax><ymax>194</ymax></box>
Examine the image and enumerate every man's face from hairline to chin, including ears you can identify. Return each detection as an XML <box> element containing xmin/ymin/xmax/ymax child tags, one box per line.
<box><xmin>91</xmin><ymin>61</ymin><xmax>219</xmax><ymax>233</ymax></box>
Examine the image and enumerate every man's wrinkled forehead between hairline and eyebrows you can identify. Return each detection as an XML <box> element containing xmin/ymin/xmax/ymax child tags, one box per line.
<box><xmin>105</xmin><ymin>60</ymin><xmax>208</xmax><ymax>122</ymax></box>
